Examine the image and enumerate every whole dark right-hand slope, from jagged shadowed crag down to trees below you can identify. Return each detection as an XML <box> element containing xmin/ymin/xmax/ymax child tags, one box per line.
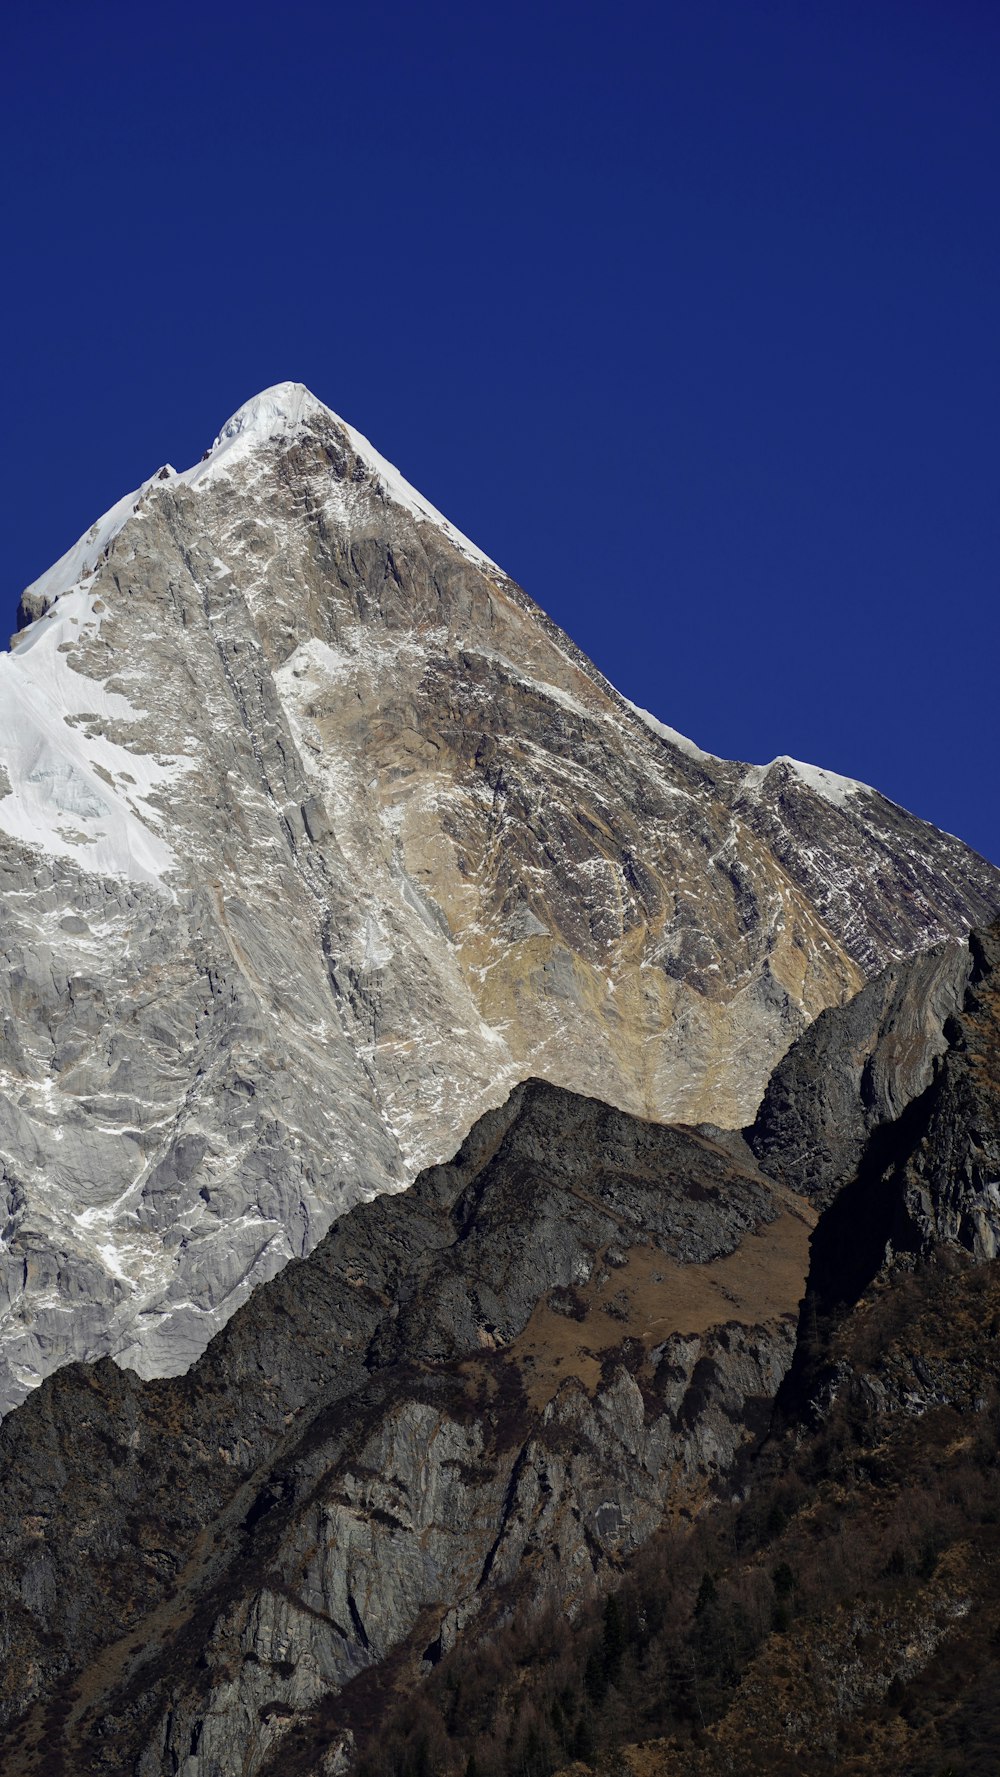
<box><xmin>321</xmin><ymin>926</ymin><xmax>1000</xmax><ymax>1777</ymax></box>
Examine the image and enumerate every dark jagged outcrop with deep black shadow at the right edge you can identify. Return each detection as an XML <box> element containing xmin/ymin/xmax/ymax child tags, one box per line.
<box><xmin>760</xmin><ymin>924</ymin><xmax>1000</xmax><ymax>1317</ymax></box>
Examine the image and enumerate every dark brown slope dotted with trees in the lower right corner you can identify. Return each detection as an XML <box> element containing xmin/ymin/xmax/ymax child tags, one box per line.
<box><xmin>358</xmin><ymin>1262</ymin><xmax>1000</xmax><ymax>1777</ymax></box>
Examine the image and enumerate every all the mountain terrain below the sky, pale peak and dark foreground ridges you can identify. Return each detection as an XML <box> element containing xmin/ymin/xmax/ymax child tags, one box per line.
<box><xmin>0</xmin><ymin>384</ymin><xmax>1000</xmax><ymax>1777</ymax></box>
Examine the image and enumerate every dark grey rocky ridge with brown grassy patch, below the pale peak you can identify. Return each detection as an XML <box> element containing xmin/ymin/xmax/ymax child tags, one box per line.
<box><xmin>0</xmin><ymin>1084</ymin><xmax>810</xmax><ymax>1777</ymax></box>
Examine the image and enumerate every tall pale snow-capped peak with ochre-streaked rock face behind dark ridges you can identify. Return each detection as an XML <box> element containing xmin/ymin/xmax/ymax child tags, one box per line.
<box><xmin>0</xmin><ymin>384</ymin><xmax>1000</xmax><ymax>1406</ymax></box>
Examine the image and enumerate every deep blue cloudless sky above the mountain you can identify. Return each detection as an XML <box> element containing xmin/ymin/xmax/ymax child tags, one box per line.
<box><xmin>0</xmin><ymin>0</ymin><xmax>1000</xmax><ymax>862</ymax></box>
